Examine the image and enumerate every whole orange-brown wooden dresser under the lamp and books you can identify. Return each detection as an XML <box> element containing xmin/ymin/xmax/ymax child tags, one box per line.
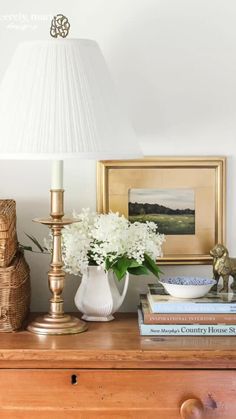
<box><xmin>0</xmin><ymin>314</ymin><xmax>236</xmax><ymax>419</ymax></box>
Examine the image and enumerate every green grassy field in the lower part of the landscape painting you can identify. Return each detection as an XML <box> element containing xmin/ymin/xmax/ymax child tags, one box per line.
<box><xmin>129</xmin><ymin>214</ymin><xmax>195</xmax><ymax>235</ymax></box>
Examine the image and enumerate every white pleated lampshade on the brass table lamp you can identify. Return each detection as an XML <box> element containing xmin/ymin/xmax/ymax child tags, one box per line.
<box><xmin>0</xmin><ymin>39</ymin><xmax>141</xmax><ymax>159</ymax></box>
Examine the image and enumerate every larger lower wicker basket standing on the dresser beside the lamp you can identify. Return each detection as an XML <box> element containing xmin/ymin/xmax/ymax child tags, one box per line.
<box><xmin>0</xmin><ymin>252</ymin><xmax>30</xmax><ymax>332</ymax></box>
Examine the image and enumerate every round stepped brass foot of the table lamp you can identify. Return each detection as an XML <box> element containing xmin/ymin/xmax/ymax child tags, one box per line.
<box><xmin>27</xmin><ymin>314</ymin><xmax>88</xmax><ymax>335</ymax></box>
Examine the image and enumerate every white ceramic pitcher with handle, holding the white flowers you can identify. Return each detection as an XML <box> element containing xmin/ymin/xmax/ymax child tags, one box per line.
<box><xmin>75</xmin><ymin>266</ymin><xmax>129</xmax><ymax>322</ymax></box>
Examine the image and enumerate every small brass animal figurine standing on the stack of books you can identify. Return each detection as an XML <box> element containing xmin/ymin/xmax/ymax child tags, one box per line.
<box><xmin>210</xmin><ymin>244</ymin><xmax>236</xmax><ymax>292</ymax></box>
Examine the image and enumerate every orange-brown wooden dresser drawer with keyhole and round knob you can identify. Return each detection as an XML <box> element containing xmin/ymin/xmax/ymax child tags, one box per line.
<box><xmin>0</xmin><ymin>369</ymin><xmax>236</xmax><ymax>419</ymax></box>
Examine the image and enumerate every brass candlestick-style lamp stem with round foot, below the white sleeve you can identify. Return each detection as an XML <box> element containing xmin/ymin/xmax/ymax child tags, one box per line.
<box><xmin>27</xmin><ymin>189</ymin><xmax>87</xmax><ymax>335</ymax></box>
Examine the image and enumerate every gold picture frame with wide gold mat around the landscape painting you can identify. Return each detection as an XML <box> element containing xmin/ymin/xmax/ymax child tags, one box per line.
<box><xmin>97</xmin><ymin>157</ymin><xmax>226</xmax><ymax>265</ymax></box>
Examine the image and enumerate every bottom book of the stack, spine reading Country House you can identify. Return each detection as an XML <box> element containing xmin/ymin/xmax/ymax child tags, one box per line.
<box><xmin>138</xmin><ymin>309</ymin><xmax>236</xmax><ymax>336</ymax></box>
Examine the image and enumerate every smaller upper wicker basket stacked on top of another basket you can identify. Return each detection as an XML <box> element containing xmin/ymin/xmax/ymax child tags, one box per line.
<box><xmin>0</xmin><ymin>199</ymin><xmax>17</xmax><ymax>267</ymax></box>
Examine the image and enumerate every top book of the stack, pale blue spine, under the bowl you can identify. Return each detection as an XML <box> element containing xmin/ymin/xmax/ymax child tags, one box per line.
<box><xmin>147</xmin><ymin>284</ymin><xmax>236</xmax><ymax>314</ymax></box>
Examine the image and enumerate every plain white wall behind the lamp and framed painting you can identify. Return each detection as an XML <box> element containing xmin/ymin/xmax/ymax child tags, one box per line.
<box><xmin>0</xmin><ymin>0</ymin><xmax>236</xmax><ymax>310</ymax></box>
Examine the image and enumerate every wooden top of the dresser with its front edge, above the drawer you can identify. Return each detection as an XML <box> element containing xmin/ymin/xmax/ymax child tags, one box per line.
<box><xmin>0</xmin><ymin>313</ymin><xmax>236</xmax><ymax>369</ymax></box>
